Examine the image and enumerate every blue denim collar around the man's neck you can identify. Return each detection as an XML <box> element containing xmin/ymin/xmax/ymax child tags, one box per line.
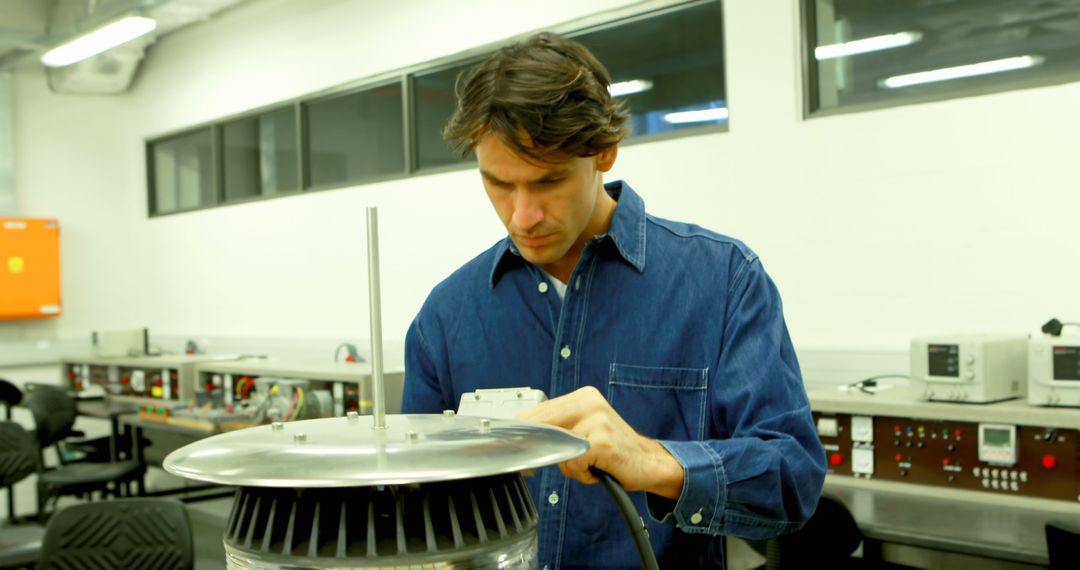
<box><xmin>490</xmin><ymin>180</ymin><xmax>645</xmax><ymax>287</ymax></box>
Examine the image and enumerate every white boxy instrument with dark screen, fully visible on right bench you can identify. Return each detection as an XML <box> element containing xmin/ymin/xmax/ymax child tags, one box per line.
<box><xmin>910</xmin><ymin>335</ymin><xmax>1028</xmax><ymax>404</ymax></box>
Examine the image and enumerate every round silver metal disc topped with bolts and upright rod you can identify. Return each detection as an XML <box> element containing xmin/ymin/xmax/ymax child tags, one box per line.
<box><xmin>164</xmin><ymin>415</ymin><xmax>589</xmax><ymax>488</ymax></box>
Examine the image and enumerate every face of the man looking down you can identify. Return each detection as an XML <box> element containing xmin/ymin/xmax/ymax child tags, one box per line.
<box><xmin>476</xmin><ymin>134</ymin><xmax>618</xmax><ymax>281</ymax></box>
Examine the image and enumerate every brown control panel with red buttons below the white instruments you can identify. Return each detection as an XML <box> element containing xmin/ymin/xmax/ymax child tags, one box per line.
<box><xmin>813</xmin><ymin>411</ymin><xmax>1080</xmax><ymax>502</ymax></box>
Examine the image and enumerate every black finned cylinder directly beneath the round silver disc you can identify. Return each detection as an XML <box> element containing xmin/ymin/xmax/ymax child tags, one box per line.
<box><xmin>225</xmin><ymin>473</ymin><xmax>539</xmax><ymax>569</ymax></box>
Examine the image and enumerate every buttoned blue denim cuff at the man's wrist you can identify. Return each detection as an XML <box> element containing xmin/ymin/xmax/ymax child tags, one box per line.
<box><xmin>646</xmin><ymin>440</ymin><xmax>728</xmax><ymax>535</ymax></box>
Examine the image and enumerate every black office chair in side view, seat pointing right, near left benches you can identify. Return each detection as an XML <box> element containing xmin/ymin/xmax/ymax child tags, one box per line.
<box><xmin>23</xmin><ymin>385</ymin><xmax>146</xmax><ymax>520</ymax></box>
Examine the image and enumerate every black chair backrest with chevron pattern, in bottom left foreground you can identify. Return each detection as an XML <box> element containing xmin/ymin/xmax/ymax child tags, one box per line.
<box><xmin>38</xmin><ymin>498</ymin><xmax>194</xmax><ymax>570</ymax></box>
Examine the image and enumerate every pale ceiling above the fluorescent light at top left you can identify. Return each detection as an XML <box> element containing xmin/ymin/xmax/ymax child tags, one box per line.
<box><xmin>0</xmin><ymin>0</ymin><xmax>246</xmax><ymax>70</ymax></box>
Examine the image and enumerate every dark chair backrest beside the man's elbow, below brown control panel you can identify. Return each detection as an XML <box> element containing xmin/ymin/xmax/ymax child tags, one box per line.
<box><xmin>766</xmin><ymin>496</ymin><xmax>863</xmax><ymax>570</ymax></box>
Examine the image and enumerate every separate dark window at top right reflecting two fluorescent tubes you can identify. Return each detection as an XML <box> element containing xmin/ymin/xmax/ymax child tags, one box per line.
<box><xmin>804</xmin><ymin>0</ymin><xmax>1080</xmax><ymax>112</ymax></box>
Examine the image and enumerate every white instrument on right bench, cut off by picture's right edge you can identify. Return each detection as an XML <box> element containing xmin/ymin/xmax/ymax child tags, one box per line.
<box><xmin>1027</xmin><ymin>335</ymin><xmax>1080</xmax><ymax>407</ymax></box>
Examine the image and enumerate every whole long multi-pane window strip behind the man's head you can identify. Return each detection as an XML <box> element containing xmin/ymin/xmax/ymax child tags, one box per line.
<box><xmin>147</xmin><ymin>0</ymin><xmax>730</xmax><ymax>216</ymax></box>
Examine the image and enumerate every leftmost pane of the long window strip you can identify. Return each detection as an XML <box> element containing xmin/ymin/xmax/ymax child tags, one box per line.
<box><xmin>149</xmin><ymin>127</ymin><xmax>215</xmax><ymax>214</ymax></box>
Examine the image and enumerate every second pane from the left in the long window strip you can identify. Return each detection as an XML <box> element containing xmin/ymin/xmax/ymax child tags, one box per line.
<box><xmin>221</xmin><ymin>107</ymin><xmax>300</xmax><ymax>202</ymax></box>
